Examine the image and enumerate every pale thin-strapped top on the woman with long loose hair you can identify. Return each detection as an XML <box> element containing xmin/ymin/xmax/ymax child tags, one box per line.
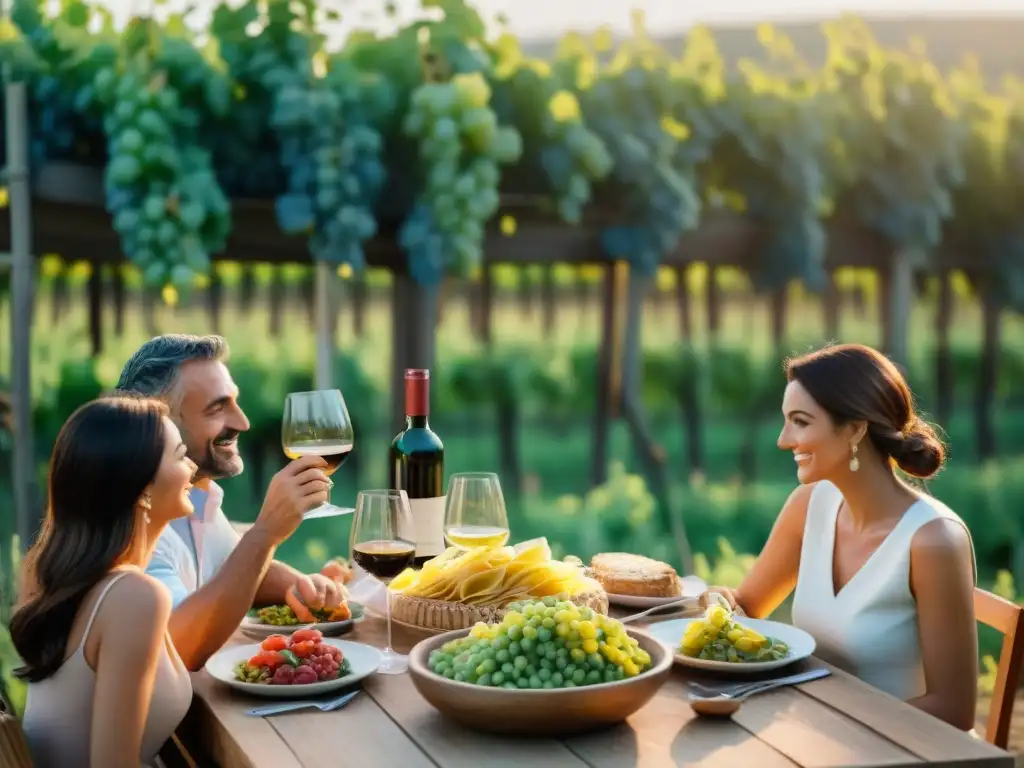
<box><xmin>23</xmin><ymin>570</ymin><xmax>193</xmax><ymax>768</ymax></box>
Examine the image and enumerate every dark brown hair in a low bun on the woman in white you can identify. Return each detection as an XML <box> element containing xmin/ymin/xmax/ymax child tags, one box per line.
<box><xmin>785</xmin><ymin>344</ymin><xmax>946</xmax><ymax>478</ymax></box>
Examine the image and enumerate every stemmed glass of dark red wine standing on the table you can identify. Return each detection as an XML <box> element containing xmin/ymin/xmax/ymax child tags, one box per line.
<box><xmin>351</xmin><ymin>490</ymin><xmax>416</xmax><ymax>675</ymax></box>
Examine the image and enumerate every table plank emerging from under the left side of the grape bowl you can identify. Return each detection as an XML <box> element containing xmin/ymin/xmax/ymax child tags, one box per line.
<box><xmin>366</xmin><ymin>675</ymin><xmax>587</xmax><ymax>768</ymax></box>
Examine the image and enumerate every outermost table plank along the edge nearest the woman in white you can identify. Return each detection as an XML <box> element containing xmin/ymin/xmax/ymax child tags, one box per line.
<box><xmin>800</xmin><ymin>659</ymin><xmax>1014</xmax><ymax>768</ymax></box>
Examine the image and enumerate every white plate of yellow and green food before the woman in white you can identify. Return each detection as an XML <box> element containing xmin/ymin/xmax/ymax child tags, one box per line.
<box><xmin>647</xmin><ymin>604</ymin><xmax>816</xmax><ymax>674</ymax></box>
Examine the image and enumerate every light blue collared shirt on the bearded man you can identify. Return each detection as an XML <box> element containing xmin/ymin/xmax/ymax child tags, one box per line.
<box><xmin>145</xmin><ymin>481</ymin><xmax>240</xmax><ymax>608</ymax></box>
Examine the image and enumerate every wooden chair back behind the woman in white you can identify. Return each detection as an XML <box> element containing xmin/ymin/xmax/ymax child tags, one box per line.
<box><xmin>974</xmin><ymin>588</ymin><xmax>1024</xmax><ymax>750</ymax></box>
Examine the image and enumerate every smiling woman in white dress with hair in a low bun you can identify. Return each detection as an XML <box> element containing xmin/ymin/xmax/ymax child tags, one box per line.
<box><xmin>708</xmin><ymin>344</ymin><xmax>978</xmax><ymax>730</ymax></box>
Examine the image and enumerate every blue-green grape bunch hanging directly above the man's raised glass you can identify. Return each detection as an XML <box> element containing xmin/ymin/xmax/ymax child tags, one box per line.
<box><xmin>205</xmin><ymin>9</ymin><xmax>386</xmax><ymax>269</ymax></box>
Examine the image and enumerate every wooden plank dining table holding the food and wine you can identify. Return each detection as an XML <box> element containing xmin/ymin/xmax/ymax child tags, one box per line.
<box><xmin>179</xmin><ymin>615</ymin><xmax>1014</xmax><ymax>768</ymax></box>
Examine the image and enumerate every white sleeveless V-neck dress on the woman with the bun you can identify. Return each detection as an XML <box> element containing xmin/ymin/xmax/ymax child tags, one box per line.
<box><xmin>793</xmin><ymin>481</ymin><xmax>977</xmax><ymax>700</ymax></box>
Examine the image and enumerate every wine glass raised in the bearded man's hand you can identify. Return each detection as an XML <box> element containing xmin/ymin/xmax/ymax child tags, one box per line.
<box><xmin>281</xmin><ymin>389</ymin><xmax>355</xmax><ymax>519</ymax></box>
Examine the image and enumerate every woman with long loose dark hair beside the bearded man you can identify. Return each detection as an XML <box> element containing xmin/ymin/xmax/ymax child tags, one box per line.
<box><xmin>10</xmin><ymin>397</ymin><xmax>196</xmax><ymax>768</ymax></box>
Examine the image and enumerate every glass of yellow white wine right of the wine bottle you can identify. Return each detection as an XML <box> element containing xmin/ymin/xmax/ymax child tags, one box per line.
<box><xmin>444</xmin><ymin>472</ymin><xmax>509</xmax><ymax>550</ymax></box>
